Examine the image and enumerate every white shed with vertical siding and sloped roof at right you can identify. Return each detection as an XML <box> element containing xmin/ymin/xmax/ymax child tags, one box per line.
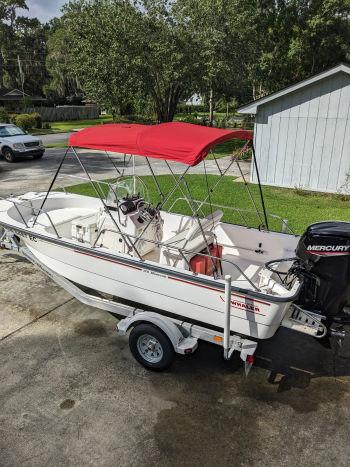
<box><xmin>238</xmin><ymin>64</ymin><xmax>350</xmax><ymax>194</ymax></box>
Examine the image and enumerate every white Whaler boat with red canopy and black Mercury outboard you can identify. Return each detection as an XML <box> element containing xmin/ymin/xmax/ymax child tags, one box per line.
<box><xmin>0</xmin><ymin>123</ymin><xmax>350</xmax><ymax>372</ymax></box>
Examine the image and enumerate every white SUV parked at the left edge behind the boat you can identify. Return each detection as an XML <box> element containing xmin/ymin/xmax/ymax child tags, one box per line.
<box><xmin>0</xmin><ymin>123</ymin><xmax>45</xmax><ymax>162</ymax></box>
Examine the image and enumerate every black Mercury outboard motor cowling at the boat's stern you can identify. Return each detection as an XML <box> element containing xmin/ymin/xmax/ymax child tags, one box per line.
<box><xmin>296</xmin><ymin>222</ymin><xmax>350</xmax><ymax>319</ymax></box>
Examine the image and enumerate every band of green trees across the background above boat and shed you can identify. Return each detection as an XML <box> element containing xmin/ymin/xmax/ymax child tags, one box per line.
<box><xmin>0</xmin><ymin>0</ymin><xmax>350</xmax><ymax>121</ymax></box>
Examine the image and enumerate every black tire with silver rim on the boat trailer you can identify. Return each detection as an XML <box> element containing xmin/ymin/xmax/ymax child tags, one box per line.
<box><xmin>129</xmin><ymin>323</ymin><xmax>175</xmax><ymax>371</ymax></box>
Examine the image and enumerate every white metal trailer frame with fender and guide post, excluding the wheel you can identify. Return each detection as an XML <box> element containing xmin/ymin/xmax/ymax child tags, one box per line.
<box><xmin>0</xmin><ymin>230</ymin><xmax>258</xmax><ymax>375</ymax></box>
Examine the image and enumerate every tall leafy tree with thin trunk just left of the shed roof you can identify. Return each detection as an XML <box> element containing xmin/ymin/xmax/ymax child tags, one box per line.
<box><xmin>175</xmin><ymin>0</ymin><xmax>257</xmax><ymax>124</ymax></box>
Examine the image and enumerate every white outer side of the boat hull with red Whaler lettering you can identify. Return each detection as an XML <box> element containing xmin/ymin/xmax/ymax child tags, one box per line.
<box><xmin>22</xmin><ymin>236</ymin><xmax>292</xmax><ymax>339</ymax></box>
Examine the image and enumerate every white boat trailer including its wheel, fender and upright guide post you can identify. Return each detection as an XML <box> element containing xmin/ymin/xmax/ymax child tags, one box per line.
<box><xmin>0</xmin><ymin>231</ymin><xmax>258</xmax><ymax>375</ymax></box>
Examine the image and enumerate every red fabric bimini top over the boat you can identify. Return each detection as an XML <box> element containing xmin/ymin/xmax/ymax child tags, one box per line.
<box><xmin>69</xmin><ymin>122</ymin><xmax>253</xmax><ymax>166</ymax></box>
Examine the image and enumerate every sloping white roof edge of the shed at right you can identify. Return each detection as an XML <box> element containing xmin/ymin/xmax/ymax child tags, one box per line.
<box><xmin>237</xmin><ymin>63</ymin><xmax>350</xmax><ymax>114</ymax></box>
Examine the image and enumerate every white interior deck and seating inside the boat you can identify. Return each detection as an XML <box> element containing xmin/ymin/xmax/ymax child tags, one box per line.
<box><xmin>2</xmin><ymin>193</ymin><xmax>297</xmax><ymax>294</ymax></box>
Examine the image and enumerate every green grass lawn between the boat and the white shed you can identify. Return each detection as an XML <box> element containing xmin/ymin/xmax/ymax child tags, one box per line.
<box><xmin>60</xmin><ymin>175</ymin><xmax>350</xmax><ymax>233</ymax></box>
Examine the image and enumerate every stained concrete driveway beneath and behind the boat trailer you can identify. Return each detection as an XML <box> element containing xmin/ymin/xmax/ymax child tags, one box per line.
<box><xmin>0</xmin><ymin>150</ymin><xmax>350</xmax><ymax>467</ymax></box>
